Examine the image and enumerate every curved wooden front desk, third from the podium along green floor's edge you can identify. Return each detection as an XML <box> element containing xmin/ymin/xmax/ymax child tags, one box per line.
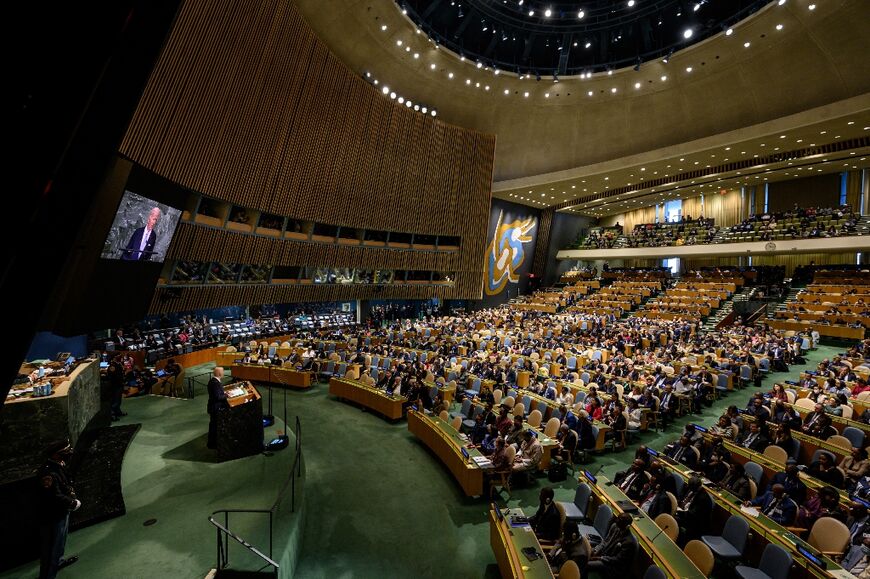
<box><xmin>408</xmin><ymin>410</ymin><xmax>484</xmax><ymax>497</ymax></box>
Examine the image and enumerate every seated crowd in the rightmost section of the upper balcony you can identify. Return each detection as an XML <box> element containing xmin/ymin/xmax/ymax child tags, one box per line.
<box><xmin>725</xmin><ymin>204</ymin><xmax>861</xmax><ymax>241</ymax></box>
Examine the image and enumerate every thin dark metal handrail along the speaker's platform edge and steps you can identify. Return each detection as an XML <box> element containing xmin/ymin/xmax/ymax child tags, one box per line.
<box><xmin>208</xmin><ymin>416</ymin><xmax>302</xmax><ymax>575</ymax></box>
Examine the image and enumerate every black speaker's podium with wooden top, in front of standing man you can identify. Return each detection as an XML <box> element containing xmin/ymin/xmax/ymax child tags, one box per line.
<box><xmin>216</xmin><ymin>382</ymin><xmax>263</xmax><ymax>462</ymax></box>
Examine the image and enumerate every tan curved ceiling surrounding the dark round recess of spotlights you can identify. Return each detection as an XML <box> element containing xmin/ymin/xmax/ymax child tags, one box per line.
<box><xmin>296</xmin><ymin>0</ymin><xmax>870</xmax><ymax>190</ymax></box>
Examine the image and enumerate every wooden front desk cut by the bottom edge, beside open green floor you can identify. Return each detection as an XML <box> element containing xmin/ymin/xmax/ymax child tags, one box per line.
<box><xmin>489</xmin><ymin>508</ymin><xmax>554</xmax><ymax>579</ymax></box>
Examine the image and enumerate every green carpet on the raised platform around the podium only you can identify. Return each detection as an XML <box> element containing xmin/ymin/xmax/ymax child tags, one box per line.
<box><xmin>0</xmin><ymin>362</ymin><xmax>293</xmax><ymax>579</ymax></box>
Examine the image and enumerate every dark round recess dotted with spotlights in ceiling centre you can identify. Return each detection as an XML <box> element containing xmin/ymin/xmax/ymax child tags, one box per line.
<box><xmin>397</xmin><ymin>0</ymin><xmax>775</xmax><ymax>78</ymax></box>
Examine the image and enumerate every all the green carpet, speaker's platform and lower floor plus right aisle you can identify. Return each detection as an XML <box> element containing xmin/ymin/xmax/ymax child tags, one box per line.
<box><xmin>0</xmin><ymin>346</ymin><xmax>856</xmax><ymax>579</ymax></box>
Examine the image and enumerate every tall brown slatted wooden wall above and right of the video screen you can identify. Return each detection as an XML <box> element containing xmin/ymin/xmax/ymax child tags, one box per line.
<box><xmin>121</xmin><ymin>0</ymin><xmax>495</xmax><ymax>311</ymax></box>
